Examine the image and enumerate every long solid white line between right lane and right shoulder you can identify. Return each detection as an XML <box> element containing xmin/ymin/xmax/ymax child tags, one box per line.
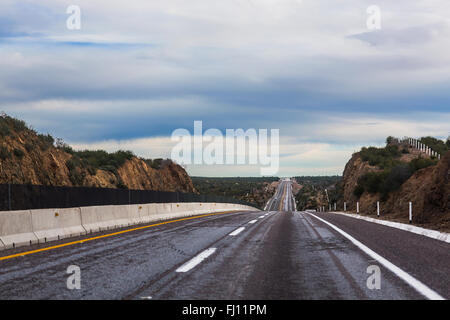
<box><xmin>306</xmin><ymin>212</ymin><xmax>445</xmax><ymax>300</ymax></box>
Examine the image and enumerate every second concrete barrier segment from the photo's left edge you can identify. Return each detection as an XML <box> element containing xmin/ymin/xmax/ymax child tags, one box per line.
<box><xmin>31</xmin><ymin>208</ymin><xmax>86</xmax><ymax>242</ymax></box>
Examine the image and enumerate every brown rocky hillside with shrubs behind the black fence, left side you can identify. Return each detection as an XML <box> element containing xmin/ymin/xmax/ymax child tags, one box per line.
<box><xmin>0</xmin><ymin>114</ymin><xmax>195</xmax><ymax>192</ymax></box>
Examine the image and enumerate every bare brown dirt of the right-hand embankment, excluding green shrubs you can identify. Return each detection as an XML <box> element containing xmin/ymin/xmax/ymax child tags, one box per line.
<box><xmin>339</xmin><ymin>150</ymin><xmax>450</xmax><ymax>232</ymax></box>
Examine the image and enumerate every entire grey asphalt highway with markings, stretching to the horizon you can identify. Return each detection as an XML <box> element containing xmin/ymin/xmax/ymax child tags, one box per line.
<box><xmin>0</xmin><ymin>180</ymin><xmax>450</xmax><ymax>300</ymax></box>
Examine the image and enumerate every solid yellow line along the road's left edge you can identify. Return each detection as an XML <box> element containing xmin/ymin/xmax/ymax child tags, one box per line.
<box><xmin>0</xmin><ymin>211</ymin><xmax>236</xmax><ymax>261</ymax></box>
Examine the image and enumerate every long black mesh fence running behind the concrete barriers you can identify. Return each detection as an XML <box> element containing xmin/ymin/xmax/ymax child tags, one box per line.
<box><xmin>0</xmin><ymin>184</ymin><xmax>255</xmax><ymax>211</ymax></box>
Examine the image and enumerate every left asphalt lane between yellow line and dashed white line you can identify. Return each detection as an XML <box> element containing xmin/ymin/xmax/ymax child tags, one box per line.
<box><xmin>0</xmin><ymin>212</ymin><xmax>261</xmax><ymax>299</ymax></box>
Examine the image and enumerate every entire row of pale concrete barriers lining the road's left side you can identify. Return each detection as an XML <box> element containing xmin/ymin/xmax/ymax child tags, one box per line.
<box><xmin>0</xmin><ymin>202</ymin><xmax>256</xmax><ymax>250</ymax></box>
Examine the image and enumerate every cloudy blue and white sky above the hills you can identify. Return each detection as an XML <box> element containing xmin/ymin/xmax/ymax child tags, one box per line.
<box><xmin>0</xmin><ymin>0</ymin><xmax>450</xmax><ymax>176</ymax></box>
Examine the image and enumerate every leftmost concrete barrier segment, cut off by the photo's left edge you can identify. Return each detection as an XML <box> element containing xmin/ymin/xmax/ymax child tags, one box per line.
<box><xmin>0</xmin><ymin>210</ymin><xmax>38</xmax><ymax>249</ymax></box>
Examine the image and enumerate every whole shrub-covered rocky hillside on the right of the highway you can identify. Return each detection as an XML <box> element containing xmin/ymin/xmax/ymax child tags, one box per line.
<box><xmin>339</xmin><ymin>138</ymin><xmax>450</xmax><ymax>231</ymax></box>
